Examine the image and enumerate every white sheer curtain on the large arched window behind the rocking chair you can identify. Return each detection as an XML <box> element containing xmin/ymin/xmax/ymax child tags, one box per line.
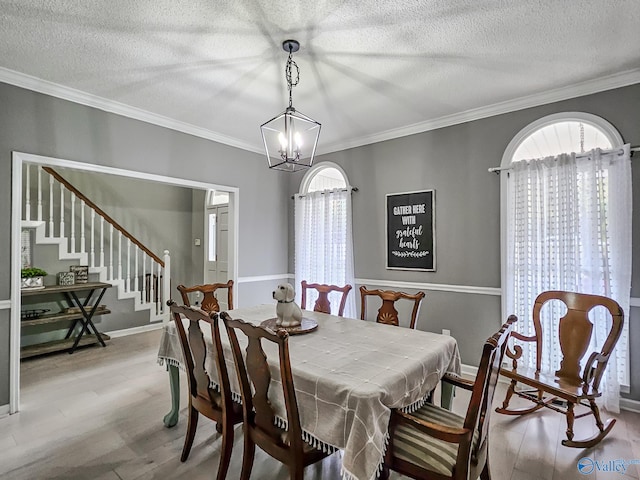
<box><xmin>505</xmin><ymin>145</ymin><xmax>632</xmax><ymax>412</ymax></box>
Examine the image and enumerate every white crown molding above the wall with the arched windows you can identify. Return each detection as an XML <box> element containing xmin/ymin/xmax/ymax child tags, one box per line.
<box><xmin>316</xmin><ymin>68</ymin><xmax>640</xmax><ymax>155</ymax></box>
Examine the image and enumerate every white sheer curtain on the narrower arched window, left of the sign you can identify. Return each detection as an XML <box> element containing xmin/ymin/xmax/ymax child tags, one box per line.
<box><xmin>295</xmin><ymin>189</ymin><xmax>356</xmax><ymax>317</ymax></box>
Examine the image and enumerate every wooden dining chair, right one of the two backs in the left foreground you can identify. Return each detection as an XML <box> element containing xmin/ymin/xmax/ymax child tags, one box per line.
<box><xmin>220</xmin><ymin>312</ymin><xmax>330</xmax><ymax>480</ymax></box>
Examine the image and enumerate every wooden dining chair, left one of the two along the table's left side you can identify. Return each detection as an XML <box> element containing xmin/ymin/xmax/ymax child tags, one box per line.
<box><xmin>167</xmin><ymin>300</ymin><xmax>242</xmax><ymax>480</ymax></box>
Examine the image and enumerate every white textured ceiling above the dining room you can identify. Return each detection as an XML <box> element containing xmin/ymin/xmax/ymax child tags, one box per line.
<box><xmin>0</xmin><ymin>0</ymin><xmax>640</xmax><ymax>152</ymax></box>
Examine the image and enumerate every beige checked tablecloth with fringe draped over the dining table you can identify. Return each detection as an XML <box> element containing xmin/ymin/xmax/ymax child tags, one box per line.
<box><xmin>158</xmin><ymin>305</ymin><xmax>460</xmax><ymax>480</ymax></box>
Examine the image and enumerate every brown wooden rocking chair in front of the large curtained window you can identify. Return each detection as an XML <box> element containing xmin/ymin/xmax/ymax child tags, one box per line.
<box><xmin>497</xmin><ymin>291</ymin><xmax>624</xmax><ymax>448</ymax></box>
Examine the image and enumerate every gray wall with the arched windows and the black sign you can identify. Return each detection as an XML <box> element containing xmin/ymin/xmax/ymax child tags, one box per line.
<box><xmin>289</xmin><ymin>84</ymin><xmax>640</xmax><ymax>399</ymax></box>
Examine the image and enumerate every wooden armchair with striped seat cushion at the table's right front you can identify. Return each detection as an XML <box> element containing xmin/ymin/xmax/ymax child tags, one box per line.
<box><xmin>380</xmin><ymin>315</ymin><xmax>517</xmax><ymax>480</ymax></box>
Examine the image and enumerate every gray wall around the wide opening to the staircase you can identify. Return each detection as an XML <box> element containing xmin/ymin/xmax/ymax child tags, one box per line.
<box><xmin>0</xmin><ymin>83</ymin><xmax>289</xmax><ymax>405</ymax></box>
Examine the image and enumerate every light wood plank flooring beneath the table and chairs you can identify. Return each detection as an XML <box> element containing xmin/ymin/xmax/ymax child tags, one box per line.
<box><xmin>0</xmin><ymin>331</ymin><xmax>640</xmax><ymax>480</ymax></box>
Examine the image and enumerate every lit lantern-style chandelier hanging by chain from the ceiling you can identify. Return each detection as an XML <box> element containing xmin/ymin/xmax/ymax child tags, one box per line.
<box><xmin>260</xmin><ymin>40</ymin><xmax>321</xmax><ymax>172</ymax></box>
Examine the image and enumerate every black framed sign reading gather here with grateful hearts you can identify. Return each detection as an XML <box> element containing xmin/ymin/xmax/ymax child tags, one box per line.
<box><xmin>386</xmin><ymin>190</ymin><xmax>436</xmax><ymax>272</ymax></box>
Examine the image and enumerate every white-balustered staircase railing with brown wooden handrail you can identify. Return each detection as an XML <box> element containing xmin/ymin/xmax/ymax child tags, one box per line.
<box><xmin>21</xmin><ymin>163</ymin><xmax>171</xmax><ymax>322</ymax></box>
